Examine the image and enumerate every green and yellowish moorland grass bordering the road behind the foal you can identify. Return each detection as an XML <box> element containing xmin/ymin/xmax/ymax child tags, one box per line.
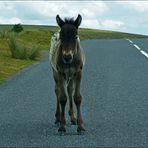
<box><xmin>0</xmin><ymin>25</ymin><xmax>148</xmax><ymax>81</ymax></box>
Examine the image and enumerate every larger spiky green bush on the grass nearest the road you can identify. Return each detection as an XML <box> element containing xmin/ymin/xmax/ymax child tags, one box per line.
<box><xmin>8</xmin><ymin>35</ymin><xmax>40</xmax><ymax>60</ymax></box>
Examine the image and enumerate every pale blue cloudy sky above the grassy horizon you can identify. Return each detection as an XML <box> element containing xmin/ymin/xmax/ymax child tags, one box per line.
<box><xmin>0</xmin><ymin>0</ymin><xmax>148</xmax><ymax>35</ymax></box>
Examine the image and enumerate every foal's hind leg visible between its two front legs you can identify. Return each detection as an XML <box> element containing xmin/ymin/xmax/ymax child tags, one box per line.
<box><xmin>67</xmin><ymin>80</ymin><xmax>76</xmax><ymax>125</ymax></box>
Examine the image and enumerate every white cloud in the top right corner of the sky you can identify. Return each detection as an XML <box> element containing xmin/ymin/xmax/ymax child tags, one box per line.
<box><xmin>117</xmin><ymin>1</ymin><xmax>148</xmax><ymax>12</ymax></box>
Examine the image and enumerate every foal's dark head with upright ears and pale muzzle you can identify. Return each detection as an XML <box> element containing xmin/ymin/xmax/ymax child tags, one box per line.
<box><xmin>56</xmin><ymin>14</ymin><xmax>82</xmax><ymax>63</ymax></box>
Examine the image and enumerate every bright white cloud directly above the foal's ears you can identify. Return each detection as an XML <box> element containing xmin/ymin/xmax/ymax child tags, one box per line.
<box><xmin>28</xmin><ymin>1</ymin><xmax>108</xmax><ymax>18</ymax></box>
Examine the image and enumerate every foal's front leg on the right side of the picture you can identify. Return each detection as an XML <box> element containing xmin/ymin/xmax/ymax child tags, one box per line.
<box><xmin>74</xmin><ymin>71</ymin><xmax>85</xmax><ymax>132</ymax></box>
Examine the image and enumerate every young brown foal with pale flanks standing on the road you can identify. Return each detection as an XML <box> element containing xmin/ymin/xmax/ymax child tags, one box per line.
<box><xmin>49</xmin><ymin>15</ymin><xmax>85</xmax><ymax>133</ymax></box>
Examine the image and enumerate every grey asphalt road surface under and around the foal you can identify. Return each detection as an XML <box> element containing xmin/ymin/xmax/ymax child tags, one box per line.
<box><xmin>0</xmin><ymin>39</ymin><xmax>148</xmax><ymax>147</ymax></box>
